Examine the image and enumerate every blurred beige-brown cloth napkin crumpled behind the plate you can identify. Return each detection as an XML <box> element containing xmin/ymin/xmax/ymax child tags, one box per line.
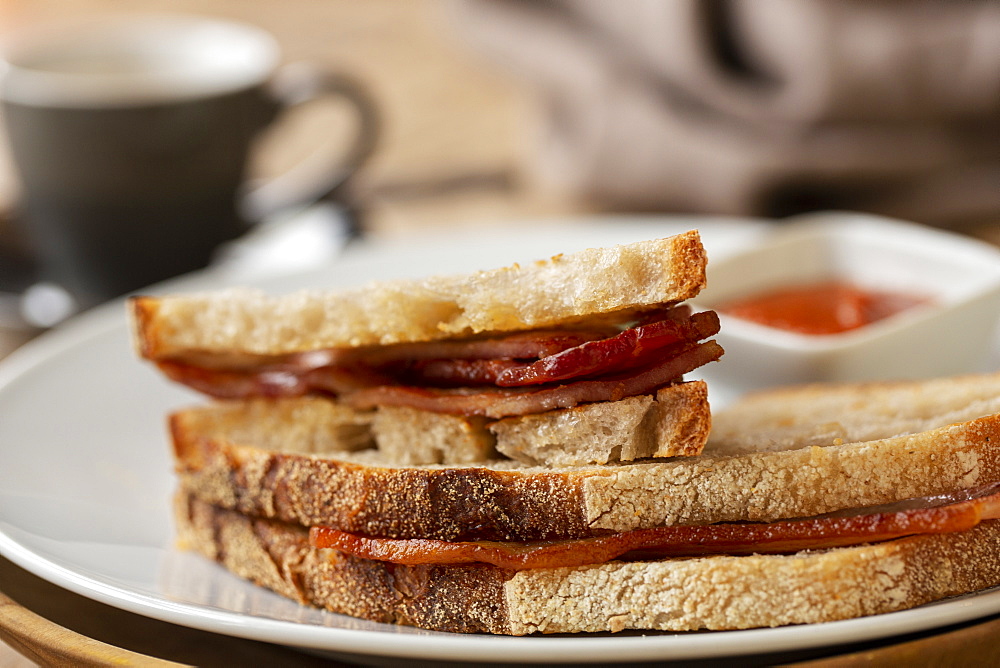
<box><xmin>457</xmin><ymin>0</ymin><xmax>1000</xmax><ymax>224</ymax></box>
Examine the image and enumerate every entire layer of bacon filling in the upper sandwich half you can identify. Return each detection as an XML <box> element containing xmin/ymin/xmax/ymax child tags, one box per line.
<box><xmin>159</xmin><ymin>306</ymin><xmax>722</xmax><ymax>417</ymax></box>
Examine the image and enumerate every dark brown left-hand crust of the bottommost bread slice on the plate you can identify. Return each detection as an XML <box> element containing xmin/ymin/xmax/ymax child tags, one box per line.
<box><xmin>175</xmin><ymin>492</ymin><xmax>513</xmax><ymax>633</ymax></box>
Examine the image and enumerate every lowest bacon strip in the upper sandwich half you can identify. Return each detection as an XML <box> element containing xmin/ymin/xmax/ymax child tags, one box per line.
<box><xmin>342</xmin><ymin>341</ymin><xmax>722</xmax><ymax>418</ymax></box>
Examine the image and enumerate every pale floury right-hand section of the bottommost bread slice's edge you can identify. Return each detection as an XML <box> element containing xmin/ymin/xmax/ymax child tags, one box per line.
<box><xmin>504</xmin><ymin>521</ymin><xmax>1000</xmax><ymax>635</ymax></box>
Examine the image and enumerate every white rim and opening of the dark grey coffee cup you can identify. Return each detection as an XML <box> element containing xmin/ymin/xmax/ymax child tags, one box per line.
<box><xmin>0</xmin><ymin>13</ymin><xmax>280</xmax><ymax>108</ymax></box>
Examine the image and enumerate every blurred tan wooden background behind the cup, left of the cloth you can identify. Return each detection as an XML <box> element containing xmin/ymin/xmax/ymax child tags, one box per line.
<box><xmin>0</xmin><ymin>0</ymin><xmax>568</xmax><ymax>258</ymax></box>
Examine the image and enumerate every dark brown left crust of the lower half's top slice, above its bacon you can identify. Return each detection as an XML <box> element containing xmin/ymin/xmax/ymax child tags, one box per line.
<box><xmin>171</xmin><ymin>411</ymin><xmax>587</xmax><ymax>540</ymax></box>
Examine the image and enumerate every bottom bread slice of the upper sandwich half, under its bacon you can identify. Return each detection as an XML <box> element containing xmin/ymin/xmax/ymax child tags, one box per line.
<box><xmin>174</xmin><ymin>381</ymin><xmax>711</xmax><ymax>466</ymax></box>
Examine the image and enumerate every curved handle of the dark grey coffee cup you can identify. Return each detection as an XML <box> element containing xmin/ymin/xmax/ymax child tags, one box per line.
<box><xmin>240</xmin><ymin>63</ymin><xmax>381</xmax><ymax>223</ymax></box>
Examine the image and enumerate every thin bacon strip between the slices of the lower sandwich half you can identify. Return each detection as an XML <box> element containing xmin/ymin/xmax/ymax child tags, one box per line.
<box><xmin>309</xmin><ymin>485</ymin><xmax>1000</xmax><ymax>570</ymax></box>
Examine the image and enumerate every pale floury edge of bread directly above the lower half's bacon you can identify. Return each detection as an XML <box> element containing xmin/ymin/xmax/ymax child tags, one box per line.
<box><xmin>583</xmin><ymin>416</ymin><xmax>1000</xmax><ymax>531</ymax></box>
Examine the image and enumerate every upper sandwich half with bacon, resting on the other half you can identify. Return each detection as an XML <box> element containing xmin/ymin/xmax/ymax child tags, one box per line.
<box><xmin>132</xmin><ymin>232</ymin><xmax>722</xmax><ymax>465</ymax></box>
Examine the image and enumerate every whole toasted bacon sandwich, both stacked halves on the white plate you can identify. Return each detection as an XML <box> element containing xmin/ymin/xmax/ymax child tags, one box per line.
<box><xmin>131</xmin><ymin>233</ymin><xmax>1000</xmax><ymax>635</ymax></box>
